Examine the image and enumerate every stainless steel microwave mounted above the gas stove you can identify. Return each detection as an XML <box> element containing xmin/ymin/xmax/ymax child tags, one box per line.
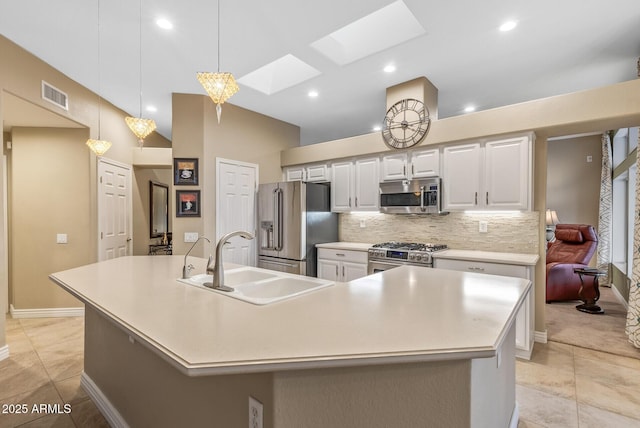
<box><xmin>380</xmin><ymin>177</ymin><xmax>445</xmax><ymax>214</ymax></box>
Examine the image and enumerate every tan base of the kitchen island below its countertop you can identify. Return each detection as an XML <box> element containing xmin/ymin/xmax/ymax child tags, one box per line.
<box><xmin>82</xmin><ymin>307</ymin><xmax>518</xmax><ymax>428</ymax></box>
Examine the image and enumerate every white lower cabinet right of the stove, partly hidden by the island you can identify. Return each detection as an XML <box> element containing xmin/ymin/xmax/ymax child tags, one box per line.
<box><xmin>433</xmin><ymin>258</ymin><xmax>535</xmax><ymax>360</ymax></box>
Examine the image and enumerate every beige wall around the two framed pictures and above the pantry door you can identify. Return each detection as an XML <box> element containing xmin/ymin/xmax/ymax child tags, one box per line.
<box><xmin>172</xmin><ymin>94</ymin><xmax>300</xmax><ymax>256</ymax></box>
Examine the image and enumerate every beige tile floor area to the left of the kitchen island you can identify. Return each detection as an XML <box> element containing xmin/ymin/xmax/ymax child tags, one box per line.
<box><xmin>0</xmin><ymin>317</ymin><xmax>109</xmax><ymax>428</ymax></box>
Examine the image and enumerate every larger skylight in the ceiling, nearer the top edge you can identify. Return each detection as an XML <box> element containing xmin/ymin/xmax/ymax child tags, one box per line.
<box><xmin>311</xmin><ymin>0</ymin><xmax>425</xmax><ymax>65</ymax></box>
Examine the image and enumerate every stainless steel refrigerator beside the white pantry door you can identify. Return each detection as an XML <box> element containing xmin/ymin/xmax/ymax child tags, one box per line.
<box><xmin>258</xmin><ymin>181</ymin><xmax>338</xmax><ymax>276</ymax></box>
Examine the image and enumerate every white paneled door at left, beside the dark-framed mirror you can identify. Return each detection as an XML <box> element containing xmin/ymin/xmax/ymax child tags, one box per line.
<box><xmin>98</xmin><ymin>159</ymin><xmax>133</xmax><ymax>261</ymax></box>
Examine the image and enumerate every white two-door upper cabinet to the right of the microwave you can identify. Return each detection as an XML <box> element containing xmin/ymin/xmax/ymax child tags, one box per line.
<box><xmin>442</xmin><ymin>136</ymin><xmax>532</xmax><ymax>210</ymax></box>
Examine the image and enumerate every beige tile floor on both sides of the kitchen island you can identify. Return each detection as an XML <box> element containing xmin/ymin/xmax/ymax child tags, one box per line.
<box><xmin>0</xmin><ymin>318</ymin><xmax>640</xmax><ymax>428</ymax></box>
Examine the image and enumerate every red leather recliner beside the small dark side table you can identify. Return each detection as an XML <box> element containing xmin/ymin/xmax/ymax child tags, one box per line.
<box><xmin>546</xmin><ymin>224</ymin><xmax>598</xmax><ymax>303</ymax></box>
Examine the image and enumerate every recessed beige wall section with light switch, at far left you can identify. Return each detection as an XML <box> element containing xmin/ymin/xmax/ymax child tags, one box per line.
<box><xmin>8</xmin><ymin>128</ymin><xmax>92</xmax><ymax>309</ymax></box>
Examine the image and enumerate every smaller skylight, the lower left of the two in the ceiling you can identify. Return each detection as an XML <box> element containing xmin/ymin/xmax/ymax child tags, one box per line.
<box><xmin>238</xmin><ymin>54</ymin><xmax>320</xmax><ymax>95</ymax></box>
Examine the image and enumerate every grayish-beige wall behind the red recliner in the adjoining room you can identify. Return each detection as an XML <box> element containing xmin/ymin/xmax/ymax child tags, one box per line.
<box><xmin>547</xmin><ymin>135</ymin><xmax>602</xmax><ymax>229</ymax></box>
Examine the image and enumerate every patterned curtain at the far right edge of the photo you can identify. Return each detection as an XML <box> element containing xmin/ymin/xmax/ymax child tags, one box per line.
<box><xmin>625</xmin><ymin>131</ymin><xmax>640</xmax><ymax>348</ymax></box>
